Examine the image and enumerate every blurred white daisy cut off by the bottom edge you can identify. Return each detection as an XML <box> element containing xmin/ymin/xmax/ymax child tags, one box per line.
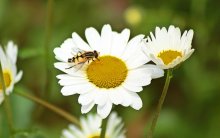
<box><xmin>61</xmin><ymin>112</ymin><xmax>125</xmax><ymax>138</ymax></box>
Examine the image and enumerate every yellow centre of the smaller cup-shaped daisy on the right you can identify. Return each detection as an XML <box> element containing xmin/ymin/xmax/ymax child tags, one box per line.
<box><xmin>158</xmin><ymin>50</ymin><xmax>182</xmax><ymax>65</ymax></box>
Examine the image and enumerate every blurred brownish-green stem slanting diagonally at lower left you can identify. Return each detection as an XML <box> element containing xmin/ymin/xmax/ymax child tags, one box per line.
<box><xmin>15</xmin><ymin>91</ymin><xmax>80</xmax><ymax>126</ymax></box>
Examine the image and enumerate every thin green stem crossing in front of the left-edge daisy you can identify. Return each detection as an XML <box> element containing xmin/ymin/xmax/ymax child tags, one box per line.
<box><xmin>0</xmin><ymin>62</ymin><xmax>14</xmax><ymax>134</ymax></box>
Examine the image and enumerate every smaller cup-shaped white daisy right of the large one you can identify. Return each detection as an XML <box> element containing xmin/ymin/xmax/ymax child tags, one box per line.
<box><xmin>143</xmin><ymin>25</ymin><xmax>194</xmax><ymax>69</ymax></box>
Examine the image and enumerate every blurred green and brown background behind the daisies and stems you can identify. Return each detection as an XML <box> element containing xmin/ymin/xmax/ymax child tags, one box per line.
<box><xmin>0</xmin><ymin>0</ymin><xmax>220</xmax><ymax>138</ymax></box>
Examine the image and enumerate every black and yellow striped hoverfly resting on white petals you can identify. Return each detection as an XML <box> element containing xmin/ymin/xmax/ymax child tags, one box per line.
<box><xmin>67</xmin><ymin>50</ymin><xmax>99</xmax><ymax>69</ymax></box>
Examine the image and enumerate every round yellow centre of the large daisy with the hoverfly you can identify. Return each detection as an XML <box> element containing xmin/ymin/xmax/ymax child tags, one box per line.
<box><xmin>86</xmin><ymin>56</ymin><xmax>128</xmax><ymax>89</ymax></box>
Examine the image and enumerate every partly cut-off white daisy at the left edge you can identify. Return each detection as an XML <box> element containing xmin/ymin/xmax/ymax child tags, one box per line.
<box><xmin>0</xmin><ymin>41</ymin><xmax>23</xmax><ymax>104</ymax></box>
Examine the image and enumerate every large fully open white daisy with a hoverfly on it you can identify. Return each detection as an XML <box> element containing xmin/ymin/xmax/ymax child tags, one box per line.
<box><xmin>54</xmin><ymin>25</ymin><xmax>164</xmax><ymax>118</ymax></box>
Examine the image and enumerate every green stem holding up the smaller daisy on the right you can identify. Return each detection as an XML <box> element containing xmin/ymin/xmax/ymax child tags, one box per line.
<box><xmin>147</xmin><ymin>69</ymin><xmax>172</xmax><ymax>138</ymax></box>
